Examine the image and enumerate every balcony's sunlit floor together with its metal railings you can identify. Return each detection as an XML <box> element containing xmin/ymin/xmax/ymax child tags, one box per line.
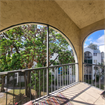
<box><xmin>0</xmin><ymin>63</ymin><xmax>105</xmax><ymax>105</ymax></box>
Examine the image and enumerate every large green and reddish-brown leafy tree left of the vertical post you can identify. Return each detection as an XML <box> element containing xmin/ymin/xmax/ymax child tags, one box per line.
<box><xmin>0</xmin><ymin>25</ymin><xmax>47</xmax><ymax>96</ymax></box>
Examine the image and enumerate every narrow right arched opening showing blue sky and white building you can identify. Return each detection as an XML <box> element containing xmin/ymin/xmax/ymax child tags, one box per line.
<box><xmin>83</xmin><ymin>30</ymin><xmax>105</xmax><ymax>89</ymax></box>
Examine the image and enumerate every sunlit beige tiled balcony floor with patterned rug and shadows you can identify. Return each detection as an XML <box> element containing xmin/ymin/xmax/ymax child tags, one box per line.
<box><xmin>33</xmin><ymin>82</ymin><xmax>105</xmax><ymax>105</ymax></box>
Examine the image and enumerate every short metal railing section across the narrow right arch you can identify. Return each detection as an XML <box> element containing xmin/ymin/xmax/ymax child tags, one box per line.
<box><xmin>83</xmin><ymin>63</ymin><xmax>105</xmax><ymax>90</ymax></box>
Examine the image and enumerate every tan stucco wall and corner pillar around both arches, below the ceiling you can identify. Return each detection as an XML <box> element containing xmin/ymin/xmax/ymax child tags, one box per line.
<box><xmin>0</xmin><ymin>0</ymin><xmax>105</xmax><ymax>80</ymax></box>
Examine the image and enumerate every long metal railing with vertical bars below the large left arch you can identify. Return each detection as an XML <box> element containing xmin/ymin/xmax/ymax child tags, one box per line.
<box><xmin>0</xmin><ymin>63</ymin><xmax>78</xmax><ymax>105</ymax></box>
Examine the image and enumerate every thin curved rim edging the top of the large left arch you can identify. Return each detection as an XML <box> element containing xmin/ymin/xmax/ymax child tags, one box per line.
<box><xmin>0</xmin><ymin>22</ymin><xmax>78</xmax><ymax>63</ymax></box>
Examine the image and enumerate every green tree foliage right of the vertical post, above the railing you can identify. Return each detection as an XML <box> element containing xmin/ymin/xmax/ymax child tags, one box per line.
<box><xmin>49</xmin><ymin>28</ymin><xmax>75</xmax><ymax>64</ymax></box>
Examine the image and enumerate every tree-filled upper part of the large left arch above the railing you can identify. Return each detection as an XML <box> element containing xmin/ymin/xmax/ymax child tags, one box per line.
<box><xmin>0</xmin><ymin>24</ymin><xmax>77</xmax><ymax>71</ymax></box>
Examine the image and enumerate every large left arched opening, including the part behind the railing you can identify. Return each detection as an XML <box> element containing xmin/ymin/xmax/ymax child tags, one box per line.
<box><xmin>0</xmin><ymin>23</ymin><xmax>78</xmax><ymax>104</ymax></box>
